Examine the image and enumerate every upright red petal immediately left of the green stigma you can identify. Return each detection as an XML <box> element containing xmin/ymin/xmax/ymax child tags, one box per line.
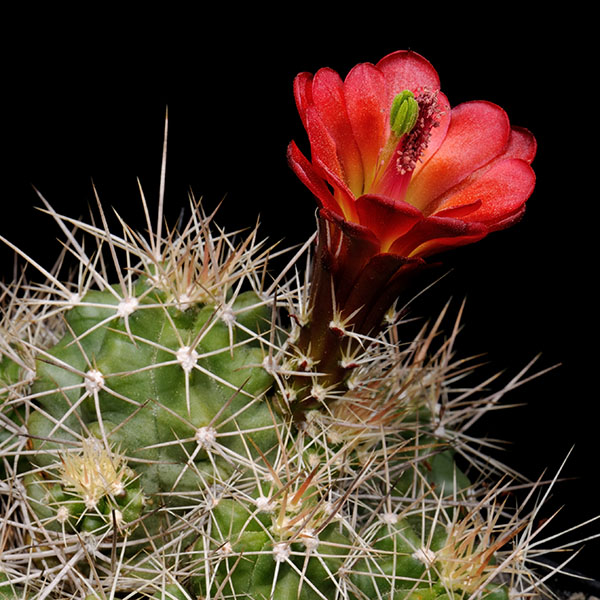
<box><xmin>344</xmin><ymin>63</ymin><xmax>389</xmax><ymax>193</ymax></box>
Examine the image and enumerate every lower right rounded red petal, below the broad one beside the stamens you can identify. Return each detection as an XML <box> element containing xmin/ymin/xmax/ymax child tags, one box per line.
<box><xmin>435</xmin><ymin>158</ymin><xmax>535</xmax><ymax>226</ymax></box>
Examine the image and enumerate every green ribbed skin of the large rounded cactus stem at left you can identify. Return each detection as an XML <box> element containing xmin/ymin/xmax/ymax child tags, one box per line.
<box><xmin>27</xmin><ymin>282</ymin><xmax>276</xmax><ymax>531</ymax></box>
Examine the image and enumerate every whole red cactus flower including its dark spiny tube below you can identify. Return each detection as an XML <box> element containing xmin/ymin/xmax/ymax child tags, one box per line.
<box><xmin>288</xmin><ymin>51</ymin><xmax>536</xmax><ymax>411</ymax></box>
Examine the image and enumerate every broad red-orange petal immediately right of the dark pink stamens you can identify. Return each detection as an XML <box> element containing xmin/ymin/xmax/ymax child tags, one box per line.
<box><xmin>406</xmin><ymin>101</ymin><xmax>510</xmax><ymax>214</ymax></box>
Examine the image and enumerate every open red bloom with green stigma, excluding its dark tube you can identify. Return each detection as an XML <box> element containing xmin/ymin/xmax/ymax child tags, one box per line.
<box><xmin>288</xmin><ymin>51</ymin><xmax>536</xmax><ymax>258</ymax></box>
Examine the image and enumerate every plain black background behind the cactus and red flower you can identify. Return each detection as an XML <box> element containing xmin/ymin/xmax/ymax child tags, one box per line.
<box><xmin>0</xmin><ymin>10</ymin><xmax>600</xmax><ymax>577</ymax></box>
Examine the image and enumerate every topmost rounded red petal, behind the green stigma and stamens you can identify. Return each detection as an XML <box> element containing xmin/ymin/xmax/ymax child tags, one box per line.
<box><xmin>376</xmin><ymin>50</ymin><xmax>440</xmax><ymax>105</ymax></box>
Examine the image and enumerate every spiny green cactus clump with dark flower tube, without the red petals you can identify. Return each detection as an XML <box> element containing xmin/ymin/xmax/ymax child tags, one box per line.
<box><xmin>0</xmin><ymin>50</ymin><xmax>596</xmax><ymax>600</ymax></box>
